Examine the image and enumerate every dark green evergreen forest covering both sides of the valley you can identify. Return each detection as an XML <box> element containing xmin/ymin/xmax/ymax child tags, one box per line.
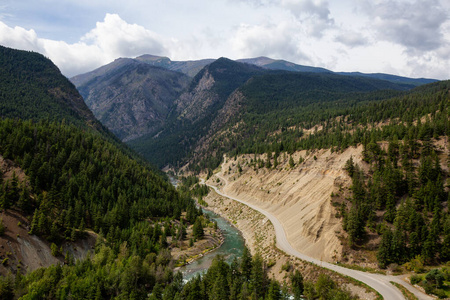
<box><xmin>0</xmin><ymin>47</ymin><xmax>450</xmax><ymax>299</ymax></box>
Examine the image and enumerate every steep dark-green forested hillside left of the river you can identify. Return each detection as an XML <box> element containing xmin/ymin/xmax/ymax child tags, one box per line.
<box><xmin>0</xmin><ymin>48</ymin><xmax>201</xmax><ymax>299</ymax></box>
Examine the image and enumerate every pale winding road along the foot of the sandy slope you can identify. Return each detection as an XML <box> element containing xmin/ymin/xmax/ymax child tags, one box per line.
<box><xmin>201</xmin><ymin>174</ymin><xmax>405</xmax><ymax>300</ymax></box>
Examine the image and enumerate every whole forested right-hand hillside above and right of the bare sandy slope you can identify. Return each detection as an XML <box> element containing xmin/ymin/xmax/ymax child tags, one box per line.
<box><xmin>198</xmin><ymin>75</ymin><xmax>450</xmax><ymax>270</ymax></box>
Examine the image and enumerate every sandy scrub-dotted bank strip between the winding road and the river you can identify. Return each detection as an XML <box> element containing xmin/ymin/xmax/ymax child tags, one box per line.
<box><xmin>203</xmin><ymin>185</ymin><xmax>377</xmax><ymax>299</ymax></box>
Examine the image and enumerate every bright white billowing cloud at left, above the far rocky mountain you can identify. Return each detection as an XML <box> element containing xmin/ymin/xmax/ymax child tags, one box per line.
<box><xmin>0</xmin><ymin>14</ymin><xmax>167</xmax><ymax>76</ymax></box>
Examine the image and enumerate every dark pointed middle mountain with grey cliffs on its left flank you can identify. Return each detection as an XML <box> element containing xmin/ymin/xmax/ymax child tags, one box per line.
<box><xmin>129</xmin><ymin>58</ymin><xmax>418</xmax><ymax>170</ymax></box>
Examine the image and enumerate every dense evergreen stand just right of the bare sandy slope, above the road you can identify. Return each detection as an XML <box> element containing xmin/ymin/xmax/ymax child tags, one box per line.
<box><xmin>341</xmin><ymin>136</ymin><xmax>450</xmax><ymax>268</ymax></box>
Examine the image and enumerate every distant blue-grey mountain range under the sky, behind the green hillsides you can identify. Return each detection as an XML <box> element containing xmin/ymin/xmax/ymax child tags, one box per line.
<box><xmin>71</xmin><ymin>55</ymin><xmax>435</xmax><ymax>167</ymax></box>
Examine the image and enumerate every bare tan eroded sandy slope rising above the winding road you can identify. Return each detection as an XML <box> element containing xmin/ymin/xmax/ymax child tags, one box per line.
<box><xmin>210</xmin><ymin>147</ymin><xmax>362</xmax><ymax>261</ymax></box>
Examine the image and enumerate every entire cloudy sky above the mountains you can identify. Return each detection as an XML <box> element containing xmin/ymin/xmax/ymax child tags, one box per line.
<box><xmin>0</xmin><ymin>0</ymin><xmax>450</xmax><ymax>79</ymax></box>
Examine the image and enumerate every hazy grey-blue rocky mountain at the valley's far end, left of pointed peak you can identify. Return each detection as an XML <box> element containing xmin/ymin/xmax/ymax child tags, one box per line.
<box><xmin>72</xmin><ymin>59</ymin><xmax>189</xmax><ymax>141</ymax></box>
